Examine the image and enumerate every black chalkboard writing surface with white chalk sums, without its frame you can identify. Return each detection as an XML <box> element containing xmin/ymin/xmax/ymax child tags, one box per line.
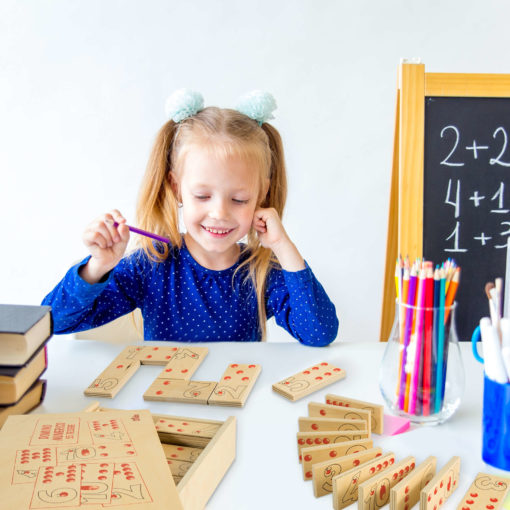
<box><xmin>423</xmin><ymin>97</ymin><xmax>510</xmax><ymax>340</ymax></box>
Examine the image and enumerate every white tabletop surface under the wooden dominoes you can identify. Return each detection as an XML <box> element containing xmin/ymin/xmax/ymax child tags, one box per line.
<box><xmin>36</xmin><ymin>336</ymin><xmax>510</xmax><ymax>510</ymax></box>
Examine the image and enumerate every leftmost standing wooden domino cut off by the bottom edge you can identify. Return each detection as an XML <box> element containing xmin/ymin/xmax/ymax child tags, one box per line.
<box><xmin>331</xmin><ymin>452</ymin><xmax>395</xmax><ymax>510</ymax></box>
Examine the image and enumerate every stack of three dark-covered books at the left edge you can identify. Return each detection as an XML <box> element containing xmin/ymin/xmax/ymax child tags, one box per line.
<box><xmin>0</xmin><ymin>304</ymin><xmax>53</xmax><ymax>427</ymax></box>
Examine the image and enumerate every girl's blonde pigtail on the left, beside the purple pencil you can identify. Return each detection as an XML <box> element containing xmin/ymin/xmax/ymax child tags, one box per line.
<box><xmin>136</xmin><ymin>120</ymin><xmax>182</xmax><ymax>262</ymax></box>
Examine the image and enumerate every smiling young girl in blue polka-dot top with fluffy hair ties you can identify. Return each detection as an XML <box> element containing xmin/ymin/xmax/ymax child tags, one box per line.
<box><xmin>43</xmin><ymin>90</ymin><xmax>338</xmax><ymax>346</ymax></box>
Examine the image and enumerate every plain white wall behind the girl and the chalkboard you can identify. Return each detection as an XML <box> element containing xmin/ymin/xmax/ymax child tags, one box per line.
<box><xmin>0</xmin><ymin>0</ymin><xmax>510</xmax><ymax>341</ymax></box>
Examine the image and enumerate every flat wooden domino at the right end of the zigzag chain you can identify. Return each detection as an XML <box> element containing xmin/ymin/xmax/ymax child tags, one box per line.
<box><xmin>208</xmin><ymin>363</ymin><xmax>261</xmax><ymax>407</ymax></box>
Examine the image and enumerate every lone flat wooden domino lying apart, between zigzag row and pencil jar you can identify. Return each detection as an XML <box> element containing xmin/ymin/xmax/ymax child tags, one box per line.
<box><xmin>273</xmin><ymin>361</ymin><xmax>346</xmax><ymax>401</ymax></box>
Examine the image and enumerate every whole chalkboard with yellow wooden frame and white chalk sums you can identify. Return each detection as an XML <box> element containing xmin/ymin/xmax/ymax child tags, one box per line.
<box><xmin>380</xmin><ymin>59</ymin><xmax>510</xmax><ymax>341</ymax></box>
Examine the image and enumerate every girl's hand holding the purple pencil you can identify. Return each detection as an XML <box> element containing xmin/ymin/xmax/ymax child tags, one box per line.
<box><xmin>80</xmin><ymin>209</ymin><xmax>129</xmax><ymax>283</ymax></box>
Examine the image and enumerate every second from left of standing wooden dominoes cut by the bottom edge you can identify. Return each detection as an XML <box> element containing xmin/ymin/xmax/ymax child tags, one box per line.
<box><xmin>358</xmin><ymin>456</ymin><xmax>415</xmax><ymax>510</ymax></box>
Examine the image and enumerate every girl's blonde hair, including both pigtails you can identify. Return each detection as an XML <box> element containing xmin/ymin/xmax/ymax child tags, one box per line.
<box><xmin>137</xmin><ymin>106</ymin><xmax>287</xmax><ymax>340</ymax></box>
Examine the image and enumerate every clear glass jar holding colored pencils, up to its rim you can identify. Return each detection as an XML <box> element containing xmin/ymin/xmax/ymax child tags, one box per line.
<box><xmin>379</xmin><ymin>301</ymin><xmax>464</xmax><ymax>425</ymax></box>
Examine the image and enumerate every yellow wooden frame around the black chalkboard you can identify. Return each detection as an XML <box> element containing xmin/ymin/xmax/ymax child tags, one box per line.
<box><xmin>379</xmin><ymin>62</ymin><xmax>510</xmax><ymax>342</ymax></box>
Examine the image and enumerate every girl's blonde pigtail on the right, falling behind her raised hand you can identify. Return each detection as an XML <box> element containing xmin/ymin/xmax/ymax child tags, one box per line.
<box><xmin>238</xmin><ymin>123</ymin><xmax>287</xmax><ymax>341</ymax></box>
